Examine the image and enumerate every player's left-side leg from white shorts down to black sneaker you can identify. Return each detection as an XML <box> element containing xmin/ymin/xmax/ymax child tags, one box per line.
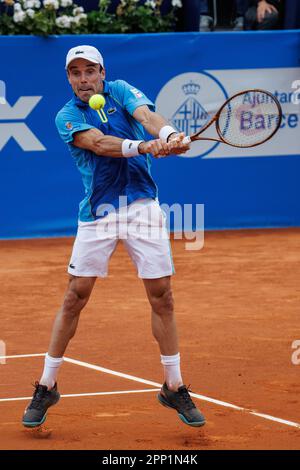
<box><xmin>23</xmin><ymin>217</ymin><xmax>117</xmax><ymax>427</ymax></box>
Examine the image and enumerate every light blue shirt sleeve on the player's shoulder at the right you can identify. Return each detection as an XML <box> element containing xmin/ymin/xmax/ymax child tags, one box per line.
<box><xmin>113</xmin><ymin>80</ymin><xmax>155</xmax><ymax>115</ymax></box>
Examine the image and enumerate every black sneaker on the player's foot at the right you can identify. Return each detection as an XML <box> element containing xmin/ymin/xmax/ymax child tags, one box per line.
<box><xmin>157</xmin><ymin>383</ymin><xmax>205</xmax><ymax>427</ymax></box>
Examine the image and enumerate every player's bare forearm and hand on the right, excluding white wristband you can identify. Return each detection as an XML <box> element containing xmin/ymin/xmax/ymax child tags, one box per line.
<box><xmin>132</xmin><ymin>105</ymin><xmax>190</xmax><ymax>154</ymax></box>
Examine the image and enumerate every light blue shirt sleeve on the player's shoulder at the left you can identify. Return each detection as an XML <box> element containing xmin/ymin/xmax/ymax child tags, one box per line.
<box><xmin>55</xmin><ymin>108</ymin><xmax>93</xmax><ymax>144</ymax></box>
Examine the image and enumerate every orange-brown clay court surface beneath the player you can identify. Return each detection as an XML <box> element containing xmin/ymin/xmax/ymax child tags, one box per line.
<box><xmin>0</xmin><ymin>229</ymin><xmax>300</xmax><ymax>450</ymax></box>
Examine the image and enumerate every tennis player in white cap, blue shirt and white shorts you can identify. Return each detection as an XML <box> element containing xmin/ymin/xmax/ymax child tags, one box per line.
<box><xmin>23</xmin><ymin>46</ymin><xmax>205</xmax><ymax>427</ymax></box>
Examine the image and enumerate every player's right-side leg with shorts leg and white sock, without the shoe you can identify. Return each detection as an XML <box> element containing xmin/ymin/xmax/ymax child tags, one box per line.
<box><xmin>124</xmin><ymin>199</ymin><xmax>182</xmax><ymax>390</ymax></box>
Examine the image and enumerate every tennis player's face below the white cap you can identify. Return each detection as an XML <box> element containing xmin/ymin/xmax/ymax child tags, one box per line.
<box><xmin>67</xmin><ymin>59</ymin><xmax>105</xmax><ymax>103</ymax></box>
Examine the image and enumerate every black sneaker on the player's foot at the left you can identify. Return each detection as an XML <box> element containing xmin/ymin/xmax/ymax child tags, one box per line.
<box><xmin>22</xmin><ymin>382</ymin><xmax>60</xmax><ymax>428</ymax></box>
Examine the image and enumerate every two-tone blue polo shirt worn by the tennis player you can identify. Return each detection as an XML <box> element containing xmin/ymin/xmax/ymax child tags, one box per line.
<box><xmin>55</xmin><ymin>80</ymin><xmax>157</xmax><ymax>222</ymax></box>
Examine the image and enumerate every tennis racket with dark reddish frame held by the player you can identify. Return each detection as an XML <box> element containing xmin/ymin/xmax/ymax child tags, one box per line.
<box><xmin>182</xmin><ymin>89</ymin><xmax>282</xmax><ymax>148</ymax></box>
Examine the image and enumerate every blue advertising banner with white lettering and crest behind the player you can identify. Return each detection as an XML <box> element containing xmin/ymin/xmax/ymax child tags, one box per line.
<box><xmin>0</xmin><ymin>31</ymin><xmax>300</xmax><ymax>238</ymax></box>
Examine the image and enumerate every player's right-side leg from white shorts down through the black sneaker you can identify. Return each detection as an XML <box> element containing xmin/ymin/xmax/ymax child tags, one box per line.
<box><xmin>124</xmin><ymin>201</ymin><xmax>205</xmax><ymax>426</ymax></box>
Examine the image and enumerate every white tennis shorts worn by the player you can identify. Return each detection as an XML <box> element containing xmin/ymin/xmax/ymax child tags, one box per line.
<box><xmin>68</xmin><ymin>199</ymin><xmax>175</xmax><ymax>279</ymax></box>
